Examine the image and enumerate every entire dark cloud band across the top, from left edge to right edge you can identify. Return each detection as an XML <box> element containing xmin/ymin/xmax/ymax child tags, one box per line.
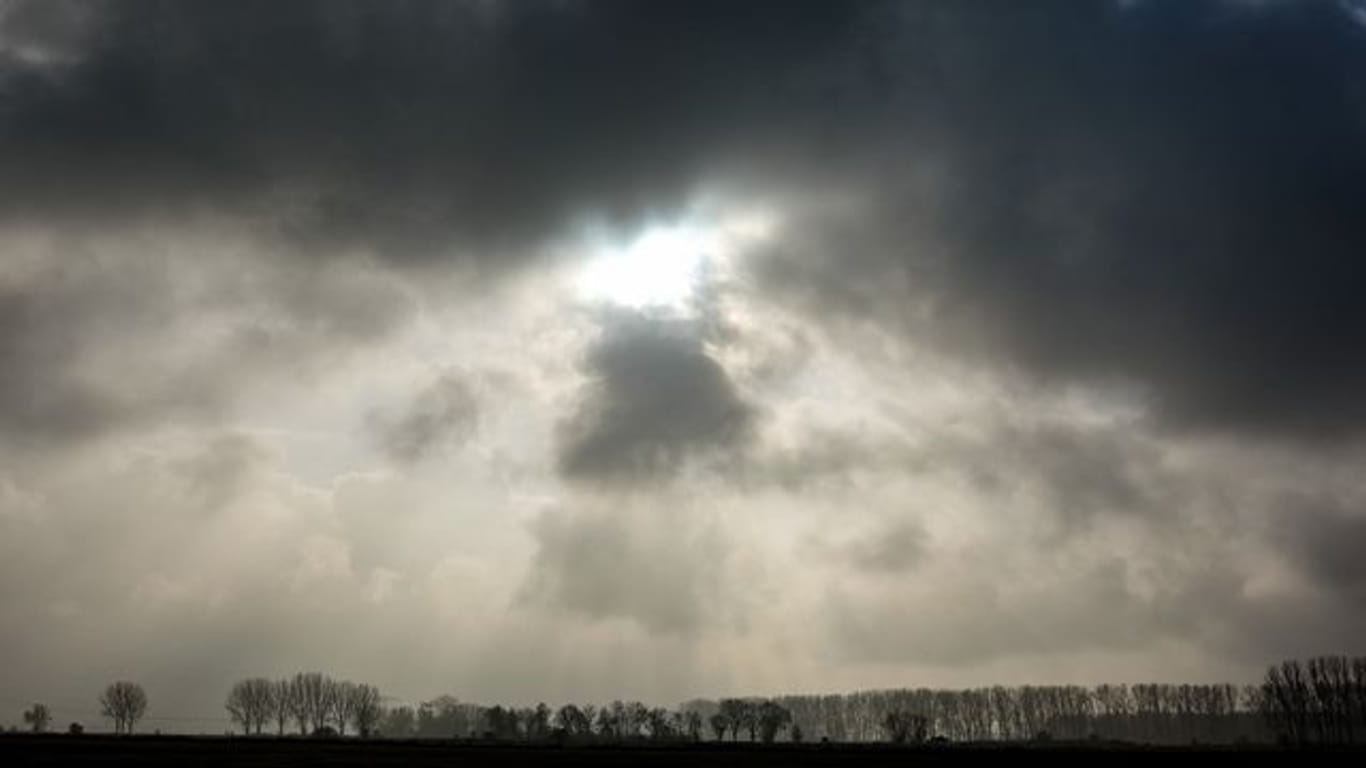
<box><xmin>13</xmin><ymin>1</ymin><xmax>1366</xmax><ymax>436</ymax></box>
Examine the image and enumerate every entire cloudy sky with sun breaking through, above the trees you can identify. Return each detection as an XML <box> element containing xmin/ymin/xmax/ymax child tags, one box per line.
<box><xmin>0</xmin><ymin>0</ymin><xmax>1366</xmax><ymax>731</ymax></box>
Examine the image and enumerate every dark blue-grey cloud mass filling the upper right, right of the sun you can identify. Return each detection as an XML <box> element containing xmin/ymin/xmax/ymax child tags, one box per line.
<box><xmin>762</xmin><ymin>3</ymin><xmax>1366</xmax><ymax>436</ymax></box>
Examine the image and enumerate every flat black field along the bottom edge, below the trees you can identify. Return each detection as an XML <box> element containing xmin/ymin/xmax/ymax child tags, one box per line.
<box><xmin>0</xmin><ymin>734</ymin><xmax>1362</xmax><ymax>767</ymax></box>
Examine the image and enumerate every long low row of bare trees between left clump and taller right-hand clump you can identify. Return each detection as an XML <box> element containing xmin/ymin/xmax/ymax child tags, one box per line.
<box><xmin>380</xmin><ymin>683</ymin><xmax>1273</xmax><ymax>743</ymax></box>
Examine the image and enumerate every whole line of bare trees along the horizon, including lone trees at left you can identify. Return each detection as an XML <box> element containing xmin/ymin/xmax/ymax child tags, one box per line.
<box><xmin>23</xmin><ymin>656</ymin><xmax>1366</xmax><ymax>745</ymax></box>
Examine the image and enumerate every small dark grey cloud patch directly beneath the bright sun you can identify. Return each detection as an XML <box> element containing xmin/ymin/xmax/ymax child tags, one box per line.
<box><xmin>559</xmin><ymin>312</ymin><xmax>755</xmax><ymax>485</ymax></box>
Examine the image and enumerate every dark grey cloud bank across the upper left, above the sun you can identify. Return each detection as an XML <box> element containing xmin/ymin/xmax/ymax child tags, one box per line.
<box><xmin>0</xmin><ymin>1</ymin><xmax>852</xmax><ymax>260</ymax></box>
